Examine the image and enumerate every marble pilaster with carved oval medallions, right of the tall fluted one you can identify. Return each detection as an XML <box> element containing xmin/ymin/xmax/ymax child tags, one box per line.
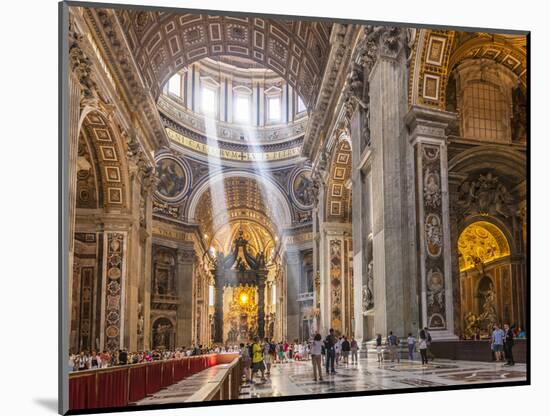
<box><xmin>407</xmin><ymin>107</ymin><xmax>457</xmax><ymax>339</ymax></box>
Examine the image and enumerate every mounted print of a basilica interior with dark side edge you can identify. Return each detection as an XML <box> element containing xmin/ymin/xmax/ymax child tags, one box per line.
<box><xmin>59</xmin><ymin>1</ymin><xmax>530</xmax><ymax>414</ymax></box>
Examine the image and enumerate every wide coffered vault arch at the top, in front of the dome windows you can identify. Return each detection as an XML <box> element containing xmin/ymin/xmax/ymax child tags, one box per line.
<box><xmin>117</xmin><ymin>9</ymin><xmax>331</xmax><ymax>106</ymax></box>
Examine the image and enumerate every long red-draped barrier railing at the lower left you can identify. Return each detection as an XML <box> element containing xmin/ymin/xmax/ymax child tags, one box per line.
<box><xmin>69</xmin><ymin>354</ymin><xmax>240</xmax><ymax>410</ymax></box>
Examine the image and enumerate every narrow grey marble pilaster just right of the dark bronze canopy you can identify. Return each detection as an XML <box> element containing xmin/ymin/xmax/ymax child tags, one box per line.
<box><xmin>284</xmin><ymin>248</ymin><xmax>301</xmax><ymax>342</ymax></box>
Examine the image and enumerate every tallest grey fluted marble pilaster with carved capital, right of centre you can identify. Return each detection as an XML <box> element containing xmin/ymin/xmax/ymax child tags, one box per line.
<box><xmin>367</xmin><ymin>26</ymin><xmax>418</xmax><ymax>337</ymax></box>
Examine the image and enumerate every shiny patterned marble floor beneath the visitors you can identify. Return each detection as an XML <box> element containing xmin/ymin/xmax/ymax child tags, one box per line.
<box><xmin>136</xmin><ymin>359</ymin><xmax>527</xmax><ymax>405</ymax></box>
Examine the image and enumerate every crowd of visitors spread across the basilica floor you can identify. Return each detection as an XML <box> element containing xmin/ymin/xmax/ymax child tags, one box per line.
<box><xmin>69</xmin><ymin>324</ymin><xmax>525</xmax><ymax>376</ymax></box>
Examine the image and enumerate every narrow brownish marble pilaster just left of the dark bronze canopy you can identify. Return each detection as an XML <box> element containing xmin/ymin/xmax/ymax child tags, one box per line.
<box><xmin>176</xmin><ymin>243</ymin><xmax>195</xmax><ymax>348</ymax></box>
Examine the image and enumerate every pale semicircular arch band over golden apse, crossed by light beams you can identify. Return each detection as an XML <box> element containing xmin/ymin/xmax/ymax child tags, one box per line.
<box><xmin>185</xmin><ymin>170</ymin><xmax>292</xmax><ymax>227</ymax></box>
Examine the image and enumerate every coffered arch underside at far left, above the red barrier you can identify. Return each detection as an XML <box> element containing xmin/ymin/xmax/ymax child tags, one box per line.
<box><xmin>79</xmin><ymin>108</ymin><xmax>129</xmax><ymax>209</ymax></box>
